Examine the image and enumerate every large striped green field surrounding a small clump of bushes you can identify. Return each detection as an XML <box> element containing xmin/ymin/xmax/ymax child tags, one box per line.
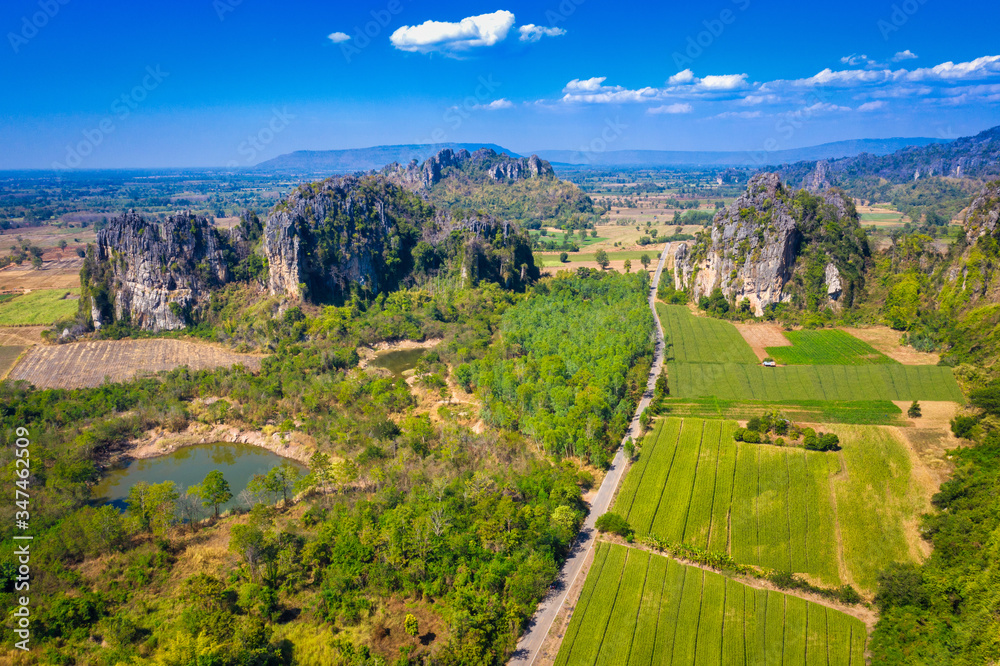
<box><xmin>613</xmin><ymin>418</ymin><xmax>926</xmax><ymax>590</ymax></box>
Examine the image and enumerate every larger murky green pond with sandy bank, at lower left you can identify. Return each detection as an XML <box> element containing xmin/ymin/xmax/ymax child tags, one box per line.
<box><xmin>91</xmin><ymin>442</ymin><xmax>306</xmax><ymax>515</ymax></box>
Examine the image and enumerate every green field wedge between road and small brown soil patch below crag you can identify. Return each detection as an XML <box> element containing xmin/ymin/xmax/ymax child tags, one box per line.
<box><xmin>656</xmin><ymin>303</ymin><xmax>758</xmax><ymax>365</ymax></box>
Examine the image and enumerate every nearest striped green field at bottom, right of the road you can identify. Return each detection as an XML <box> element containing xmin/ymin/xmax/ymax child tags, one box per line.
<box><xmin>555</xmin><ymin>542</ymin><xmax>866</xmax><ymax>666</ymax></box>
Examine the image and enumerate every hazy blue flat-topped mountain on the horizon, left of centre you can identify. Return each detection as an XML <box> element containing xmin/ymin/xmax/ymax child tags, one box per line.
<box><xmin>249</xmin><ymin>143</ymin><xmax>520</xmax><ymax>176</ymax></box>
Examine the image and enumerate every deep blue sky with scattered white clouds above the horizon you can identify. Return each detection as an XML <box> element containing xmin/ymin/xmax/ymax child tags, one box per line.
<box><xmin>0</xmin><ymin>0</ymin><xmax>1000</xmax><ymax>169</ymax></box>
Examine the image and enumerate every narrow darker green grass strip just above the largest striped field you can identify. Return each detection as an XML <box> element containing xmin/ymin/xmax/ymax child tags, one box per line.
<box><xmin>663</xmin><ymin>398</ymin><xmax>905</xmax><ymax>425</ymax></box>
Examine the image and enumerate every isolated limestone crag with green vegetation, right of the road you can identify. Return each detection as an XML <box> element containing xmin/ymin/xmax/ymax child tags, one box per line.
<box><xmin>675</xmin><ymin>173</ymin><xmax>870</xmax><ymax>316</ymax></box>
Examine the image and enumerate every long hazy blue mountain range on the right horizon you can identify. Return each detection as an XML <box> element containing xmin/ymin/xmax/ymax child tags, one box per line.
<box><xmin>535</xmin><ymin>137</ymin><xmax>947</xmax><ymax>167</ymax></box>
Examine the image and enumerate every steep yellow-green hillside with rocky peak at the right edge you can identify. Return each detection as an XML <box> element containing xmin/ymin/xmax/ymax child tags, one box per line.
<box><xmin>863</xmin><ymin>180</ymin><xmax>1000</xmax><ymax>368</ymax></box>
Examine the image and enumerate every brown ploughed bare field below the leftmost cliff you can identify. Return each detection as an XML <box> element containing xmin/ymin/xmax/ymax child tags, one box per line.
<box><xmin>9</xmin><ymin>340</ymin><xmax>263</xmax><ymax>389</ymax></box>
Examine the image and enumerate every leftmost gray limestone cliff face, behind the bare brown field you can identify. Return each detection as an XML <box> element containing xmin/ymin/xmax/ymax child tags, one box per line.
<box><xmin>90</xmin><ymin>211</ymin><xmax>229</xmax><ymax>331</ymax></box>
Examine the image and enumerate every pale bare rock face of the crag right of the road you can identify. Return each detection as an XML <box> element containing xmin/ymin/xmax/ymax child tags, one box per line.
<box><xmin>675</xmin><ymin>173</ymin><xmax>801</xmax><ymax>316</ymax></box>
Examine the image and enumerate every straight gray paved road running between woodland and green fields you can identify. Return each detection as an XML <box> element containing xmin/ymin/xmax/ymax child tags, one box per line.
<box><xmin>507</xmin><ymin>243</ymin><xmax>670</xmax><ymax>666</ymax></box>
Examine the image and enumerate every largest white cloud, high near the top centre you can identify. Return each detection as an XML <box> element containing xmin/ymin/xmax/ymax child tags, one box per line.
<box><xmin>389</xmin><ymin>10</ymin><xmax>514</xmax><ymax>53</ymax></box>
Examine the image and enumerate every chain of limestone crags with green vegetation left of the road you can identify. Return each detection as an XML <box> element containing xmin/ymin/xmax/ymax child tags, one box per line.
<box><xmin>79</xmin><ymin>150</ymin><xmax>556</xmax><ymax>331</ymax></box>
